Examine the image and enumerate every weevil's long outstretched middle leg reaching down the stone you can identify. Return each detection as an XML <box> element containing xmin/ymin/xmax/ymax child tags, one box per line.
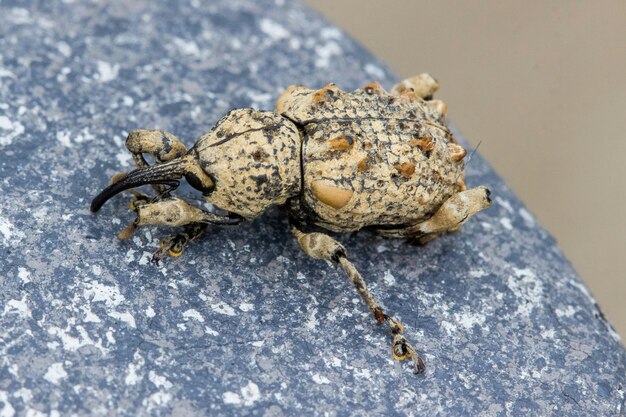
<box><xmin>292</xmin><ymin>227</ymin><xmax>425</xmax><ymax>373</ymax></box>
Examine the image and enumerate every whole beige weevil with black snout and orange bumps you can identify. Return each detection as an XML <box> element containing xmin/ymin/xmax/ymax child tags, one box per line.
<box><xmin>91</xmin><ymin>74</ymin><xmax>491</xmax><ymax>373</ymax></box>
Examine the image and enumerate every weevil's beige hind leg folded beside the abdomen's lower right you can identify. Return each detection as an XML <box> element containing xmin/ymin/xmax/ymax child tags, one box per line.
<box><xmin>377</xmin><ymin>186</ymin><xmax>491</xmax><ymax>244</ymax></box>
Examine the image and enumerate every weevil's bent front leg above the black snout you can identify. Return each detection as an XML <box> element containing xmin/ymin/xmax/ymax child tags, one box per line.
<box><xmin>122</xmin><ymin>129</ymin><xmax>187</xmax><ymax>194</ymax></box>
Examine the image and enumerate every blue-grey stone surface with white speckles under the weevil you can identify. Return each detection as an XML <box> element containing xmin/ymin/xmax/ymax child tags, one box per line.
<box><xmin>0</xmin><ymin>0</ymin><xmax>626</xmax><ymax>417</ymax></box>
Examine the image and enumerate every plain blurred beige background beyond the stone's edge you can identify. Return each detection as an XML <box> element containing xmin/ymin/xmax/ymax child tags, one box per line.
<box><xmin>309</xmin><ymin>0</ymin><xmax>626</xmax><ymax>339</ymax></box>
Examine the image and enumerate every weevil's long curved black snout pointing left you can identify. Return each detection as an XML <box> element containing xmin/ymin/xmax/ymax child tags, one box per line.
<box><xmin>91</xmin><ymin>158</ymin><xmax>188</xmax><ymax>213</ymax></box>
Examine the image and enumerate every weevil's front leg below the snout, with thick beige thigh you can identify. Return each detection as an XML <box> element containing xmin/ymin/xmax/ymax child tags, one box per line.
<box><xmin>118</xmin><ymin>197</ymin><xmax>243</xmax><ymax>261</ymax></box>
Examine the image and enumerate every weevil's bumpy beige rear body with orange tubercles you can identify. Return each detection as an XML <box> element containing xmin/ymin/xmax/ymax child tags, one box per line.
<box><xmin>276</xmin><ymin>79</ymin><xmax>465</xmax><ymax>232</ymax></box>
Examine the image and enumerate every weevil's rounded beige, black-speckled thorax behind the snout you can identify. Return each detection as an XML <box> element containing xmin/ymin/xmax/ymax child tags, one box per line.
<box><xmin>195</xmin><ymin>109</ymin><xmax>301</xmax><ymax>219</ymax></box>
